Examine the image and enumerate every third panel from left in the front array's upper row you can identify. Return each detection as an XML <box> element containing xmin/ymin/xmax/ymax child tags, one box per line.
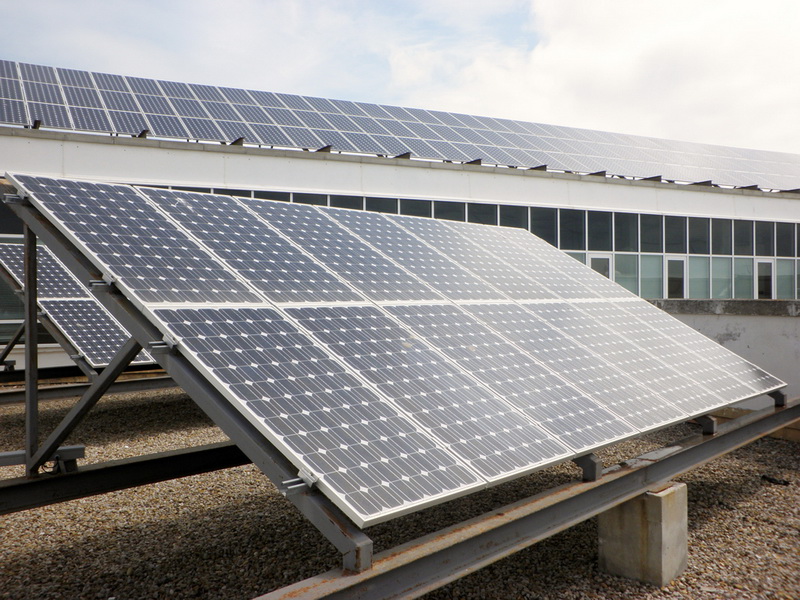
<box><xmin>245</xmin><ymin>200</ymin><xmax>441</xmax><ymax>300</ymax></box>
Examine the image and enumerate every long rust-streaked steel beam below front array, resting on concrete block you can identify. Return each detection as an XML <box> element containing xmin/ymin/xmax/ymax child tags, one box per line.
<box><xmin>257</xmin><ymin>400</ymin><xmax>800</xmax><ymax>600</ymax></box>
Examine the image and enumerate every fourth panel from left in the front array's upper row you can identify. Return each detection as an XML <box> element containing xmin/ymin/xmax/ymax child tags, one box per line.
<box><xmin>327</xmin><ymin>208</ymin><xmax>505</xmax><ymax>300</ymax></box>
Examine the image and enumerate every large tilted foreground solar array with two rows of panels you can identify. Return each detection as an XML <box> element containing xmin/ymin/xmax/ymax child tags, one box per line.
<box><xmin>4</xmin><ymin>175</ymin><xmax>783</xmax><ymax>526</ymax></box>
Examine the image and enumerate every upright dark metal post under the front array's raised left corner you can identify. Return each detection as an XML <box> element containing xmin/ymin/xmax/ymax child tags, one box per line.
<box><xmin>23</xmin><ymin>225</ymin><xmax>39</xmax><ymax>477</ymax></box>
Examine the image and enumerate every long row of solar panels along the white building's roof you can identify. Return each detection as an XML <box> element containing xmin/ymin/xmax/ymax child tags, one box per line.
<box><xmin>0</xmin><ymin>61</ymin><xmax>800</xmax><ymax>190</ymax></box>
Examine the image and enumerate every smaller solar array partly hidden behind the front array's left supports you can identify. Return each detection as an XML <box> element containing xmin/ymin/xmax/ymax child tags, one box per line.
<box><xmin>0</xmin><ymin>244</ymin><xmax>153</xmax><ymax>368</ymax></box>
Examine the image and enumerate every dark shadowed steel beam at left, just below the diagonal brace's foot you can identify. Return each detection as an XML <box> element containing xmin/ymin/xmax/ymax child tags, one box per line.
<box><xmin>0</xmin><ymin>442</ymin><xmax>250</xmax><ymax>515</ymax></box>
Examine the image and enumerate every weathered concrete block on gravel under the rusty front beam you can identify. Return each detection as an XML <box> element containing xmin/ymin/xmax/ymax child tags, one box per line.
<box><xmin>597</xmin><ymin>482</ymin><xmax>688</xmax><ymax>587</ymax></box>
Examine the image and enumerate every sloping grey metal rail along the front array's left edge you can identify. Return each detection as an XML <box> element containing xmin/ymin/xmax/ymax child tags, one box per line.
<box><xmin>6</xmin><ymin>196</ymin><xmax>372</xmax><ymax>572</ymax></box>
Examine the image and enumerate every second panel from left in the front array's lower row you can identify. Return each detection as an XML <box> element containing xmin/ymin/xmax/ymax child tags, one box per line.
<box><xmin>287</xmin><ymin>306</ymin><xmax>568</xmax><ymax>481</ymax></box>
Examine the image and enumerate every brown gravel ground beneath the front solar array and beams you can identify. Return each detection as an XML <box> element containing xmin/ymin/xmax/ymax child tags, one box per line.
<box><xmin>0</xmin><ymin>391</ymin><xmax>800</xmax><ymax>600</ymax></box>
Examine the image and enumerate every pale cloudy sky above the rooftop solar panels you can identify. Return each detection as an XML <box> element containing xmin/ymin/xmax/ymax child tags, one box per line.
<box><xmin>0</xmin><ymin>0</ymin><xmax>800</xmax><ymax>153</ymax></box>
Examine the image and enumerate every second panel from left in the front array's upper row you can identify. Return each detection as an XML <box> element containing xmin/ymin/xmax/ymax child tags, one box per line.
<box><xmin>142</xmin><ymin>188</ymin><xmax>363</xmax><ymax>302</ymax></box>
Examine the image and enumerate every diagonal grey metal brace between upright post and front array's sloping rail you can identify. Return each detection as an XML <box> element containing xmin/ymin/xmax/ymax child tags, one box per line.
<box><xmin>27</xmin><ymin>338</ymin><xmax>142</xmax><ymax>473</ymax></box>
